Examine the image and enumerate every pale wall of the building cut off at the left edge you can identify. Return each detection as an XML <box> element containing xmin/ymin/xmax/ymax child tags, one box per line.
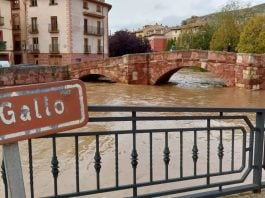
<box><xmin>0</xmin><ymin>0</ymin><xmax>13</xmax><ymax>51</ymax></box>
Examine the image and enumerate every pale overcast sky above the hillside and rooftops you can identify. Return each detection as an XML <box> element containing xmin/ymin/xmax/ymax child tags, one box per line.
<box><xmin>105</xmin><ymin>0</ymin><xmax>265</xmax><ymax>33</ymax></box>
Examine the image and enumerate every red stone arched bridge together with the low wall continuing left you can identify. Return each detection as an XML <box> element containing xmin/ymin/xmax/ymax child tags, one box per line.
<box><xmin>0</xmin><ymin>50</ymin><xmax>265</xmax><ymax>89</ymax></box>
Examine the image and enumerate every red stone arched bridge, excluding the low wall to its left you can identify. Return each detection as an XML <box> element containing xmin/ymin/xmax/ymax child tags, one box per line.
<box><xmin>70</xmin><ymin>50</ymin><xmax>265</xmax><ymax>89</ymax></box>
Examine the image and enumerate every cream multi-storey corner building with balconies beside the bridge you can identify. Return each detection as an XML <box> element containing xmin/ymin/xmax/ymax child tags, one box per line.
<box><xmin>0</xmin><ymin>0</ymin><xmax>111</xmax><ymax>65</ymax></box>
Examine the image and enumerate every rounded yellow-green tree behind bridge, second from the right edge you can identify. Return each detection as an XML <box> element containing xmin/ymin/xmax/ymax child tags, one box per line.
<box><xmin>210</xmin><ymin>17</ymin><xmax>240</xmax><ymax>51</ymax></box>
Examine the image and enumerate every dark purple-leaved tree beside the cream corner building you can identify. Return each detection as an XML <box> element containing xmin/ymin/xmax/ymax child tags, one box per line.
<box><xmin>109</xmin><ymin>30</ymin><xmax>151</xmax><ymax>57</ymax></box>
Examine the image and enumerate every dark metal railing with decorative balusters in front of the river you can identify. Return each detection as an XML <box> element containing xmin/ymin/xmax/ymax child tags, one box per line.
<box><xmin>2</xmin><ymin>106</ymin><xmax>265</xmax><ymax>197</ymax></box>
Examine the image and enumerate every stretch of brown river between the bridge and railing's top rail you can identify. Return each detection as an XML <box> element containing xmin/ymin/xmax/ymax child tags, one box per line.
<box><xmin>86</xmin><ymin>70</ymin><xmax>265</xmax><ymax>107</ymax></box>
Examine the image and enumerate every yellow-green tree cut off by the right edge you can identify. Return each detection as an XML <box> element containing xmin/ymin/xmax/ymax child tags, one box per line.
<box><xmin>237</xmin><ymin>16</ymin><xmax>265</xmax><ymax>53</ymax></box>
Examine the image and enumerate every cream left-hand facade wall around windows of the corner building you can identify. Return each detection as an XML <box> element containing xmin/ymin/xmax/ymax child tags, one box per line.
<box><xmin>27</xmin><ymin>0</ymin><xmax>71</xmax><ymax>53</ymax></box>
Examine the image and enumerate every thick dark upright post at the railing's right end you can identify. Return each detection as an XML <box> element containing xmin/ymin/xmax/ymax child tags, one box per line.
<box><xmin>253</xmin><ymin>112</ymin><xmax>265</xmax><ymax>193</ymax></box>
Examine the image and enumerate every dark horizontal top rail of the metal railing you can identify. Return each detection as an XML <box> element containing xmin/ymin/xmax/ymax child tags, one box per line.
<box><xmin>88</xmin><ymin>105</ymin><xmax>265</xmax><ymax>113</ymax></box>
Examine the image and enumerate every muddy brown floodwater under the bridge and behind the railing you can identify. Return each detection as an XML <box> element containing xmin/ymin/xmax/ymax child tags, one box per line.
<box><xmin>2</xmin><ymin>67</ymin><xmax>265</xmax><ymax>197</ymax></box>
